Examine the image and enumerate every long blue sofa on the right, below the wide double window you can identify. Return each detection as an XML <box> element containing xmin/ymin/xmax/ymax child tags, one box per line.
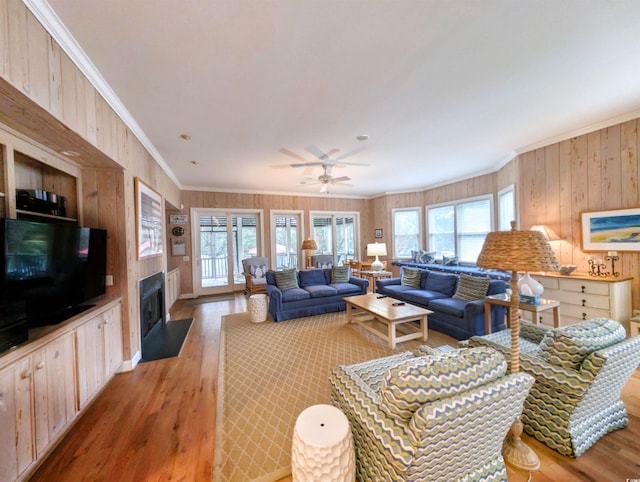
<box><xmin>376</xmin><ymin>268</ymin><xmax>506</xmax><ymax>340</ymax></box>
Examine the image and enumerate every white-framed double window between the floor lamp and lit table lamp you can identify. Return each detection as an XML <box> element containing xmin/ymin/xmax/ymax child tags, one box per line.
<box><xmin>311</xmin><ymin>213</ymin><xmax>360</xmax><ymax>263</ymax></box>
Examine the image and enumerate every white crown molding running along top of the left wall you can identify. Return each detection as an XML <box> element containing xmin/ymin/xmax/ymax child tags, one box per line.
<box><xmin>22</xmin><ymin>0</ymin><xmax>182</xmax><ymax>189</ymax></box>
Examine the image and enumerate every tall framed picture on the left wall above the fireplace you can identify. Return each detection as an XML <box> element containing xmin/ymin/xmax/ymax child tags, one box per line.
<box><xmin>135</xmin><ymin>177</ymin><xmax>163</xmax><ymax>259</ymax></box>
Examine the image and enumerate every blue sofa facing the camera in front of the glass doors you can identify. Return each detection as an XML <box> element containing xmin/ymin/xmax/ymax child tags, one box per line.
<box><xmin>267</xmin><ymin>268</ymin><xmax>369</xmax><ymax>321</ymax></box>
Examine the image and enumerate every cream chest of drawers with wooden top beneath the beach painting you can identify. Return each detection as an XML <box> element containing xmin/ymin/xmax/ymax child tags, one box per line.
<box><xmin>522</xmin><ymin>273</ymin><xmax>633</xmax><ymax>333</ymax></box>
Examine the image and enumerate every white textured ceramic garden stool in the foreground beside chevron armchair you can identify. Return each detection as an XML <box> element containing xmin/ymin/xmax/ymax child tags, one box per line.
<box><xmin>291</xmin><ymin>405</ymin><xmax>356</xmax><ymax>482</ymax></box>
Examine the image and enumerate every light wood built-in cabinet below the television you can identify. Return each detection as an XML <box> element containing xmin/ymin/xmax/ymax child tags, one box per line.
<box><xmin>0</xmin><ymin>299</ymin><xmax>123</xmax><ymax>482</ymax></box>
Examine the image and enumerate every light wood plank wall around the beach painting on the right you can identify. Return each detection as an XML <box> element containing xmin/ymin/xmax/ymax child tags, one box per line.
<box><xmin>513</xmin><ymin>119</ymin><xmax>640</xmax><ymax>309</ymax></box>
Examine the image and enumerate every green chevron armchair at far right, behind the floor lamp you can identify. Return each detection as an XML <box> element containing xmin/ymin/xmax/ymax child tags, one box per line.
<box><xmin>467</xmin><ymin>318</ymin><xmax>640</xmax><ymax>457</ymax></box>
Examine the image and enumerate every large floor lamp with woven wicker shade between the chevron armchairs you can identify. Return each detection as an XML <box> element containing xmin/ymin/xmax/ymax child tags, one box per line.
<box><xmin>476</xmin><ymin>221</ymin><xmax>560</xmax><ymax>471</ymax></box>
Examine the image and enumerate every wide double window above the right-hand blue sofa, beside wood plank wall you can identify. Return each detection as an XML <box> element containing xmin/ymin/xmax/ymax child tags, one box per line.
<box><xmin>427</xmin><ymin>196</ymin><xmax>493</xmax><ymax>263</ymax></box>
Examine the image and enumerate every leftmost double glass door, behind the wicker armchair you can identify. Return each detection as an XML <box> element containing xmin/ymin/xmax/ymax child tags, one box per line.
<box><xmin>192</xmin><ymin>209</ymin><xmax>261</xmax><ymax>296</ymax></box>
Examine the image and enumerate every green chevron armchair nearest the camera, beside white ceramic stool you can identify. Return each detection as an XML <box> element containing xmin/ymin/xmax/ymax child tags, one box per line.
<box><xmin>330</xmin><ymin>347</ymin><xmax>533</xmax><ymax>482</ymax></box>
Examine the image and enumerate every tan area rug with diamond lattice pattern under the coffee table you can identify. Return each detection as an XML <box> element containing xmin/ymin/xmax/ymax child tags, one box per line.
<box><xmin>213</xmin><ymin>312</ymin><xmax>436</xmax><ymax>482</ymax></box>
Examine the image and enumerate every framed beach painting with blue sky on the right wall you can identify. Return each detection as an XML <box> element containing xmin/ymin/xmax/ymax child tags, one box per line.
<box><xmin>582</xmin><ymin>208</ymin><xmax>640</xmax><ymax>251</ymax></box>
